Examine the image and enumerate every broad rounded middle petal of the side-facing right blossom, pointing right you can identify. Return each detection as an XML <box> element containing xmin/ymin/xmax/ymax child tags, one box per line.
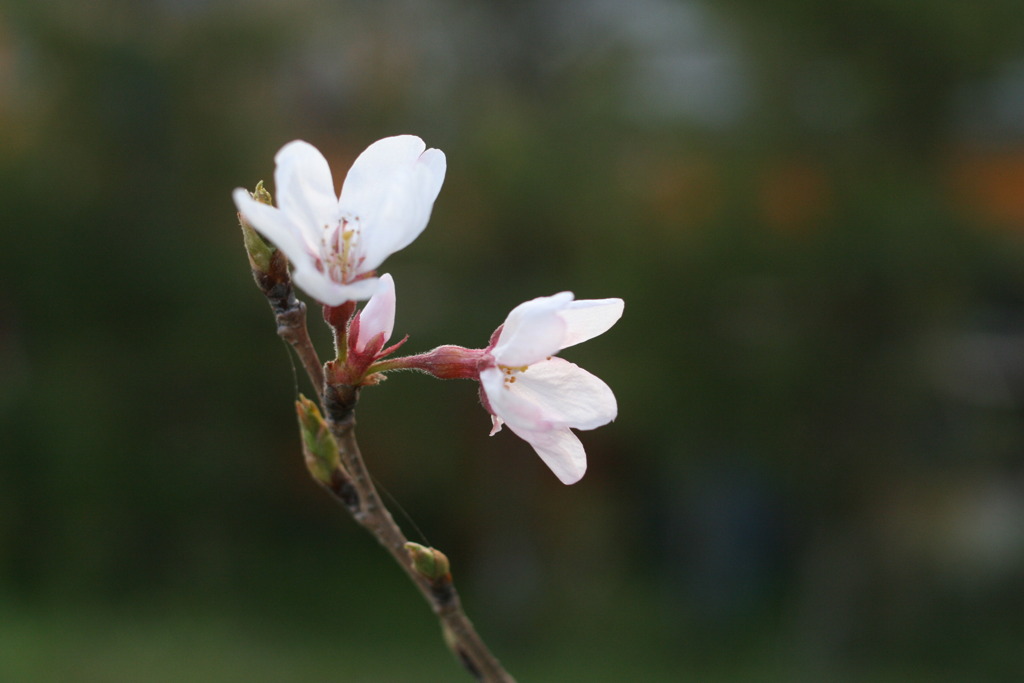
<box><xmin>503</xmin><ymin>357</ymin><xmax>618</xmax><ymax>429</ymax></box>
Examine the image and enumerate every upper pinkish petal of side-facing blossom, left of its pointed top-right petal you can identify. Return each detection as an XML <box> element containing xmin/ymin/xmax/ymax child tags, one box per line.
<box><xmin>493</xmin><ymin>292</ymin><xmax>572</xmax><ymax>367</ymax></box>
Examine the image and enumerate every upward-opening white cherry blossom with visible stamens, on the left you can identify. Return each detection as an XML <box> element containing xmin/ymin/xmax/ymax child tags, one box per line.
<box><xmin>239</xmin><ymin>135</ymin><xmax>445</xmax><ymax>306</ymax></box>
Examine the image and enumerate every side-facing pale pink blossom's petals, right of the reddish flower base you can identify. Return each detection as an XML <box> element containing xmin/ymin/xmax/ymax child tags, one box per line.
<box><xmin>479</xmin><ymin>292</ymin><xmax>624</xmax><ymax>484</ymax></box>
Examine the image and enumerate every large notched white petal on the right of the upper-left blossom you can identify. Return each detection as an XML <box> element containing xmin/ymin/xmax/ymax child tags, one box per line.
<box><xmin>340</xmin><ymin>135</ymin><xmax>445</xmax><ymax>272</ymax></box>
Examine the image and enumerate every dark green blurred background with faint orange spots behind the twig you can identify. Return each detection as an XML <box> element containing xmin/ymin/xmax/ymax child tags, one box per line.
<box><xmin>0</xmin><ymin>0</ymin><xmax>1024</xmax><ymax>683</ymax></box>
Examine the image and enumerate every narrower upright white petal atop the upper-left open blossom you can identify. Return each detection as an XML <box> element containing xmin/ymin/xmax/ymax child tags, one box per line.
<box><xmin>273</xmin><ymin>140</ymin><xmax>339</xmax><ymax>244</ymax></box>
